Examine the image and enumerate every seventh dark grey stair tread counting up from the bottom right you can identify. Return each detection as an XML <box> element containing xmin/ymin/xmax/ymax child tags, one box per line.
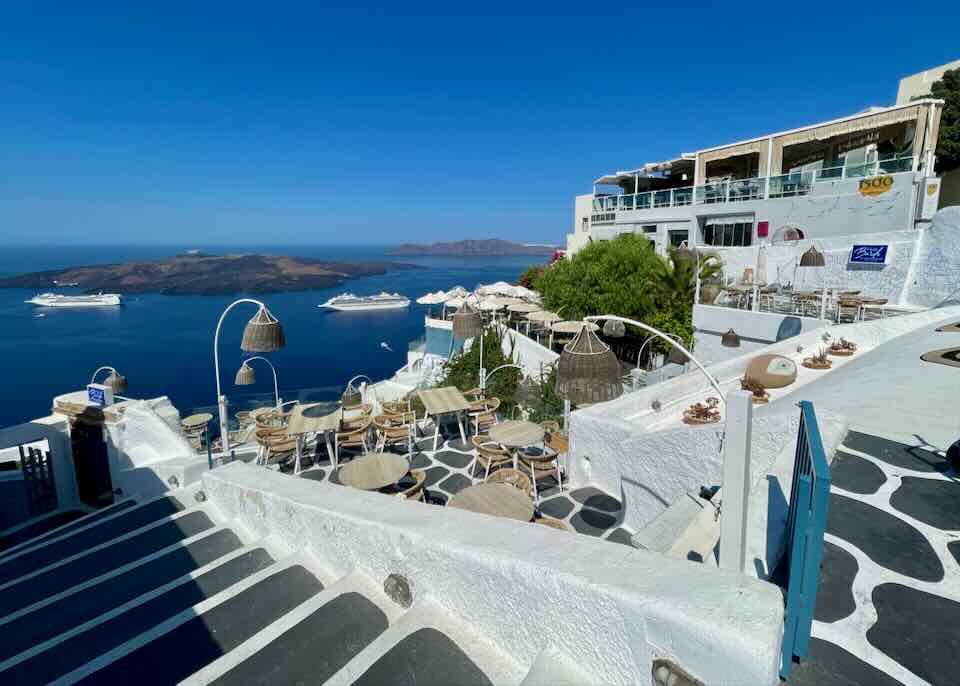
<box><xmin>0</xmin><ymin>496</ymin><xmax>184</xmax><ymax>585</ymax></box>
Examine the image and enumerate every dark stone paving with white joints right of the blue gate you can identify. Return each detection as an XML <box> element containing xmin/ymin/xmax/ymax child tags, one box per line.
<box><xmin>789</xmin><ymin>431</ymin><xmax>960</xmax><ymax>686</ymax></box>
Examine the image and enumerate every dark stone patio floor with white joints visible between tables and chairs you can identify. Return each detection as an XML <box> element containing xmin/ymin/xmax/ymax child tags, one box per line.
<box><xmin>300</xmin><ymin>429</ymin><xmax>631</xmax><ymax>546</ymax></box>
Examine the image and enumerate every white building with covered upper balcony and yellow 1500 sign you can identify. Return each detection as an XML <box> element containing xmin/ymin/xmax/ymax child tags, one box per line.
<box><xmin>567</xmin><ymin>98</ymin><xmax>943</xmax><ymax>255</ymax></box>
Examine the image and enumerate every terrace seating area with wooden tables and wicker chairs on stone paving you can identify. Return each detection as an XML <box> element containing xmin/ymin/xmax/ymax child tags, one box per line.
<box><xmin>219</xmin><ymin>378</ymin><xmax>630</xmax><ymax>544</ymax></box>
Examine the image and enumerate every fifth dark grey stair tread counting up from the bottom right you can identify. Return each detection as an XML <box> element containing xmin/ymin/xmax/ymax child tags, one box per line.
<box><xmin>0</xmin><ymin>529</ymin><xmax>243</xmax><ymax>662</ymax></box>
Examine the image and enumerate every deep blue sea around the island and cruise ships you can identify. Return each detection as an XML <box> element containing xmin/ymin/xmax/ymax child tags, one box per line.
<box><xmin>0</xmin><ymin>245</ymin><xmax>542</xmax><ymax>427</ymax></box>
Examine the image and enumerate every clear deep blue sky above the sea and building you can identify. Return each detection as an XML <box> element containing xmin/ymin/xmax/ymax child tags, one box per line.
<box><xmin>0</xmin><ymin>0</ymin><xmax>960</xmax><ymax>245</ymax></box>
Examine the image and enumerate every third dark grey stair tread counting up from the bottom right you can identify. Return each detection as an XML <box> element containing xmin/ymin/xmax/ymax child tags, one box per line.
<box><xmin>67</xmin><ymin>564</ymin><xmax>323</xmax><ymax>686</ymax></box>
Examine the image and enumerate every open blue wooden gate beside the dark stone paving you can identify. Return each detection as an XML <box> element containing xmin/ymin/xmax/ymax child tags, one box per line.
<box><xmin>780</xmin><ymin>400</ymin><xmax>830</xmax><ymax>679</ymax></box>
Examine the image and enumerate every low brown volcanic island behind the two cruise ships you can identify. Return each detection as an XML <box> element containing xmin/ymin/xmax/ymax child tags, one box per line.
<box><xmin>0</xmin><ymin>253</ymin><xmax>418</xmax><ymax>295</ymax></box>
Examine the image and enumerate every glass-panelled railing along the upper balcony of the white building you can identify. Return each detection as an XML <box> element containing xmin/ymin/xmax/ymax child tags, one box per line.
<box><xmin>593</xmin><ymin>155</ymin><xmax>914</xmax><ymax>222</ymax></box>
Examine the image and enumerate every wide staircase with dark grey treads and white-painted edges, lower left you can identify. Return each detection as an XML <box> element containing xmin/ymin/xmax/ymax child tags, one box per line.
<box><xmin>0</xmin><ymin>488</ymin><xmax>510</xmax><ymax>686</ymax></box>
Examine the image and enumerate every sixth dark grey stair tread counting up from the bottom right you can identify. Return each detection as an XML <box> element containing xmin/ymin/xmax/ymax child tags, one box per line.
<box><xmin>0</xmin><ymin>510</ymin><xmax>214</xmax><ymax>617</ymax></box>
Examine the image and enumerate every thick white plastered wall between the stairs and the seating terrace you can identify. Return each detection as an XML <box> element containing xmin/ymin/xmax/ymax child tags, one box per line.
<box><xmin>203</xmin><ymin>463</ymin><xmax>783</xmax><ymax>686</ymax></box>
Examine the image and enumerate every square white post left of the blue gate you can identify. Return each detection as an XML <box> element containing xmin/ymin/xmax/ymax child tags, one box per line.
<box><xmin>720</xmin><ymin>391</ymin><xmax>753</xmax><ymax>574</ymax></box>
